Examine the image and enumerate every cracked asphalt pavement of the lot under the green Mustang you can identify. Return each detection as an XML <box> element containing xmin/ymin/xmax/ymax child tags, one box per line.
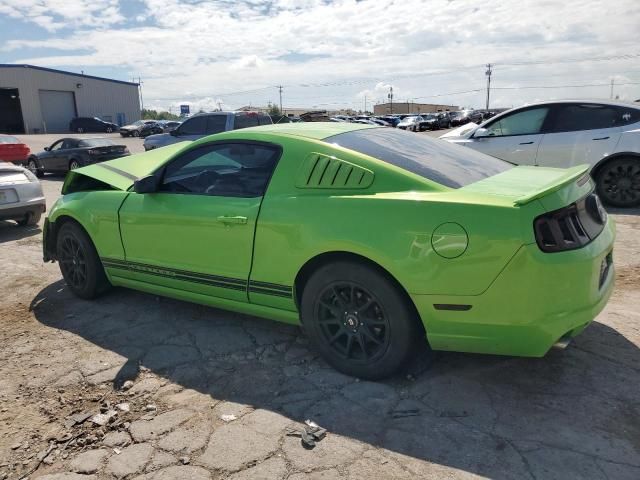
<box><xmin>0</xmin><ymin>144</ymin><xmax>640</xmax><ymax>480</ymax></box>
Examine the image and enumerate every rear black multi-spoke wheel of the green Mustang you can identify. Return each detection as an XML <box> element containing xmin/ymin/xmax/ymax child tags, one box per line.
<box><xmin>300</xmin><ymin>261</ymin><xmax>426</xmax><ymax>380</ymax></box>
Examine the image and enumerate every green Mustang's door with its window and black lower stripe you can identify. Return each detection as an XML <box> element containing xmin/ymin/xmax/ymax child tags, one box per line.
<box><xmin>120</xmin><ymin>142</ymin><xmax>281</xmax><ymax>302</ymax></box>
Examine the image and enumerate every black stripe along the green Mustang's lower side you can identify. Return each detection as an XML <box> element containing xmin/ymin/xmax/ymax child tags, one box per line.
<box><xmin>100</xmin><ymin>257</ymin><xmax>293</xmax><ymax>298</ymax></box>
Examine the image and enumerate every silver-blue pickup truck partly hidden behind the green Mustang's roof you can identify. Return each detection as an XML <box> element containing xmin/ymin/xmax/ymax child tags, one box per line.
<box><xmin>144</xmin><ymin>112</ymin><xmax>273</xmax><ymax>150</ymax></box>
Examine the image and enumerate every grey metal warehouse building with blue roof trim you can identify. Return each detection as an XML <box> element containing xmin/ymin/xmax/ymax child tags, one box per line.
<box><xmin>0</xmin><ymin>64</ymin><xmax>140</xmax><ymax>133</ymax></box>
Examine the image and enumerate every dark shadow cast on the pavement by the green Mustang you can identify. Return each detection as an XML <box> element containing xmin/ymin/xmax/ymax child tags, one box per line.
<box><xmin>31</xmin><ymin>281</ymin><xmax>640</xmax><ymax>479</ymax></box>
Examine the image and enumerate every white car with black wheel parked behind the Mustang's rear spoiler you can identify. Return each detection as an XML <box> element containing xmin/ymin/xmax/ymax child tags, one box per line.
<box><xmin>441</xmin><ymin>100</ymin><xmax>640</xmax><ymax>207</ymax></box>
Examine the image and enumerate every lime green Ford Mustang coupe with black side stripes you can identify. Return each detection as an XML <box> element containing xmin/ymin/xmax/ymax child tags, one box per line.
<box><xmin>44</xmin><ymin>123</ymin><xmax>615</xmax><ymax>378</ymax></box>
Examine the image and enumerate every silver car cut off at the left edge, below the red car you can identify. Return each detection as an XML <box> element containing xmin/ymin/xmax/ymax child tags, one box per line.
<box><xmin>0</xmin><ymin>162</ymin><xmax>46</xmax><ymax>225</ymax></box>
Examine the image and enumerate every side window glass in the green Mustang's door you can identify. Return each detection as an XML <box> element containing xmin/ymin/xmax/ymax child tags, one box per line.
<box><xmin>160</xmin><ymin>143</ymin><xmax>280</xmax><ymax>197</ymax></box>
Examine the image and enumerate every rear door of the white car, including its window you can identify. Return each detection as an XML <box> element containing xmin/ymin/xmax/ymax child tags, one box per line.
<box><xmin>536</xmin><ymin>103</ymin><xmax>623</xmax><ymax>168</ymax></box>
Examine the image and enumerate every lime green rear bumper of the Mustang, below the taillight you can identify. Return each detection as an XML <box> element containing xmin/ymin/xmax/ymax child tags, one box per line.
<box><xmin>412</xmin><ymin>220</ymin><xmax>615</xmax><ymax>357</ymax></box>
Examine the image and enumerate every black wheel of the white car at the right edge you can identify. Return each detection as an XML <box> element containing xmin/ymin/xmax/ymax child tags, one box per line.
<box><xmin>595</xmin><ymin>157</ymin><xmax>640</xmax><ymax>208</ymax></box>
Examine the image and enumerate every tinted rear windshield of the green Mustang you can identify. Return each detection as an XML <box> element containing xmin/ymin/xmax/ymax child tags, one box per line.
<box><xmin>324</xmin><ymin>127</ymin><xmax>513</xmax><ymax>188</ymax></box>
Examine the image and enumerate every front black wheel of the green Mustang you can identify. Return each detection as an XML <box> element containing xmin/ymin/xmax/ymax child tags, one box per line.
<box><xmin>56</xmin><ymin>222</ymin><xmax>110</xmax><ymax>300</ymax></box>
